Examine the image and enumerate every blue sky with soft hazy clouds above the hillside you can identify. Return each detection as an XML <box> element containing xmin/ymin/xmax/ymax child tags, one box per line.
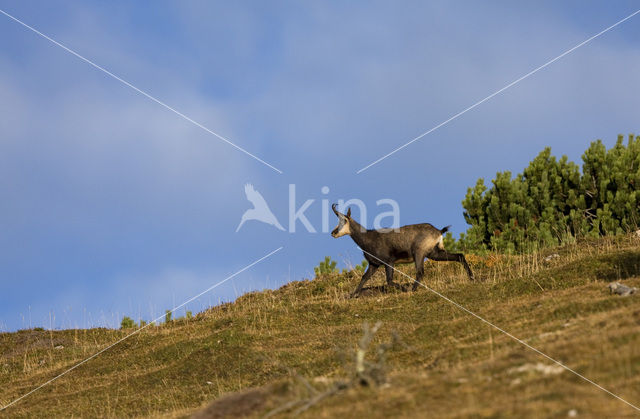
<box><xmin>0</xmin><ymin>1</ymin><xmax>640</xmax><ymax>330</ymax></box>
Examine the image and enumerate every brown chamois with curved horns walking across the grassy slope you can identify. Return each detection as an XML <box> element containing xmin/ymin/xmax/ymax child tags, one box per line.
<box><xmin>331</xmin><ymin>204</ymin><xmax>474</xmax><ymax>297</ymax></box>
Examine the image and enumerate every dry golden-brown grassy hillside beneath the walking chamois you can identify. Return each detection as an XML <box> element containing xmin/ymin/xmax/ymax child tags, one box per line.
<box><xmin>0</xmin><ymin>236</ymin><xmax>640</xmax><ymax>417</ymax></box>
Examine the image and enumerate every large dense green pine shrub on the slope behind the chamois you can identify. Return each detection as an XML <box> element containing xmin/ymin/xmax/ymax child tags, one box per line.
<box><xmin>458</xmin><ymin>135</ymin><xmax>640</xmax><ymax>253</ymax></box>
